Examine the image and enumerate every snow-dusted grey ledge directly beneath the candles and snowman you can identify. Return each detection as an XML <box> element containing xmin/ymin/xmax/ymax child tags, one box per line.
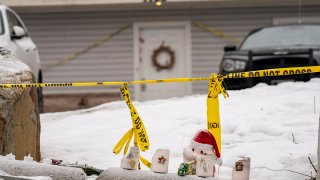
<box><xmin>97</xmin><ymin>168</ymin><xmax>218</xmax><ymax>180</ymax></box>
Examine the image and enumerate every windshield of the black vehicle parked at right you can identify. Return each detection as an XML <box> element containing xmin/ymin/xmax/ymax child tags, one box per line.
<box><xmin>240</xmin><ymin>25</ymin><xmax>320</xmax><ymax>49</ymax></box>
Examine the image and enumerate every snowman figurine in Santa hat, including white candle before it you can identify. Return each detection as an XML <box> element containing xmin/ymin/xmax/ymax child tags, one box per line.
<box><xmin>183</xmin><ymin>129</ymin><xmax>222</xmax><ymax>177</ymax></box>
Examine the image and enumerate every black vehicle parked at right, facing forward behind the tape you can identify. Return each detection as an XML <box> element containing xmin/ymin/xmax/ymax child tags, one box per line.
<box><xmin>220</xmin><ymin>24</ymin><xmax>320</xmax><ymax>89</ymax></box>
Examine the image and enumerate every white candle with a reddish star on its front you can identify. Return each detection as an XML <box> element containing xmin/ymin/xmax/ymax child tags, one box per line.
<box><xmin>151</xmin><ymin>149</ymin><xmax>170</xmax><ymax>173</ymax></box>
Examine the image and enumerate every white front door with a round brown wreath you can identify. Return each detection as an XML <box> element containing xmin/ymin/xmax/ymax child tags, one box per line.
<box><xmin>134</xmin><ymin>22</ymin><xmax>191</xmax><ymax>101</ymax></box>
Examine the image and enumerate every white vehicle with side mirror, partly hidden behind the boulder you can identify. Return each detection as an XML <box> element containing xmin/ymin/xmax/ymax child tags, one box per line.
<box><xmin>0</xmin><ymin>5</ymin><xmax>43</xmax><ymax>112</ymax></box>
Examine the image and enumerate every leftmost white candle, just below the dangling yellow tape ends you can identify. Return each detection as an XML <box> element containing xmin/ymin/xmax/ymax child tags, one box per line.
<box><xmin>120</xmin><ymin>147</ymin><xmax>140</xmax><ymax>170</ymax></box>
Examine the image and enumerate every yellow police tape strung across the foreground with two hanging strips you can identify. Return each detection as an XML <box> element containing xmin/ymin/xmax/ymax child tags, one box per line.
<box><xmin>0</xmin><ymin>66</ymin><xmax>320</xmax><ymax>168</ymax></box>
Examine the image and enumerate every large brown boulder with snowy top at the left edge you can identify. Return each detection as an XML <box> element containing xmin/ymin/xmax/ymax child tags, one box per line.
<box><xmin>0</xmin><ymin>48</ymin><xmax>41</xmax><ymax>161</ymax></box>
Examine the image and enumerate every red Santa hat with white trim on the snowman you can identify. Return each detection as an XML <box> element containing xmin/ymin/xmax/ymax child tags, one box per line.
<box><xmin>191</xmin><ymin>129</ymin><xmax>220</xmax><ymax>158</ymax></box>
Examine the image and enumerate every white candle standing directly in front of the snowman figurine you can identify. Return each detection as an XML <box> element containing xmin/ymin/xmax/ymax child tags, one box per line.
<box><xmin>196</xmin><ymin>155</ymin><xmax>215</xmax><ymax>177</ymax></box>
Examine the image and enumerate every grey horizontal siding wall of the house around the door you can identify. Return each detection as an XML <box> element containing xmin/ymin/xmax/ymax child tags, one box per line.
<box><xmin>20</xmin><ymin>6</ymin><xmax>320</xmax><ymax>94</ymax></box>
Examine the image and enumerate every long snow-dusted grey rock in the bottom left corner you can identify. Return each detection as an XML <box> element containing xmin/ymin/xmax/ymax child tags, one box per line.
<box><xmin>0</xmin><ymin>156</ymin><xmax>87</xmax><ymax>180</ymax></box>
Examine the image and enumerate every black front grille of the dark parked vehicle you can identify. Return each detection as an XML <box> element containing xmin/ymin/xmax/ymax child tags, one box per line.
<box><xmin>252</xmin><ymin>57</ymin><xmax>310</xmax><ymax>70</ymax></box>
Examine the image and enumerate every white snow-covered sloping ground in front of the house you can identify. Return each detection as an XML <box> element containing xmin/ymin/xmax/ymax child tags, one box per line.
<box><xmin>41</xmin><ymin>79</ymin><xmax>320</xmax><ymax>180</ymax></box>
